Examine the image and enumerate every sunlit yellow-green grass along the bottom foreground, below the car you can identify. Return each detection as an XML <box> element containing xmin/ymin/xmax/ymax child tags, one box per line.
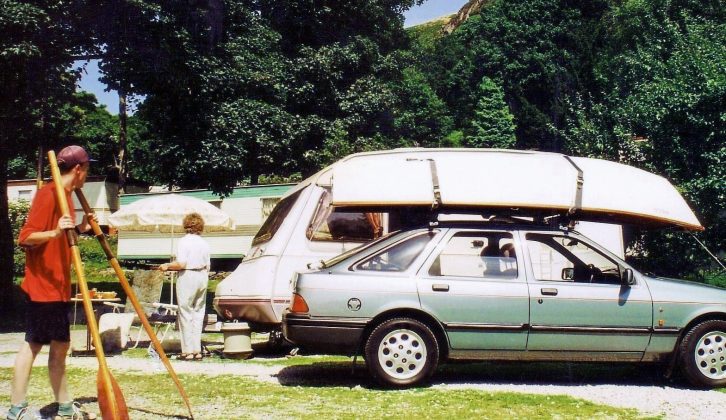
<box><xmin>0</xmin><ymin>361</ymin><xmax>639</xmax><ymax>419</ymax></box>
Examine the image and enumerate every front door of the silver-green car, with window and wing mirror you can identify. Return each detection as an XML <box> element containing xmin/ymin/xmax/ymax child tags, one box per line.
<box><xmin>524</xmin><ymin>232</ymin><xmax>652</xmax><ymax>352</ymax></box>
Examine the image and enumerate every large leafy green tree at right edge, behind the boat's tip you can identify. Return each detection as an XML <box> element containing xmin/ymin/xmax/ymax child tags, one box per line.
<box><xmin>584</xmin><ymin>0</ymin><xmax>726</xmax><ymax>276</ymax></box>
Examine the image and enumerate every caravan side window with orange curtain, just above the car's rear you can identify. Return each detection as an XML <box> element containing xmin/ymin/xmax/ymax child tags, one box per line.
<box><xmin>307</xmin><ymin>190</ymin><xmax>383</xmax><ymax>242</ymax></box>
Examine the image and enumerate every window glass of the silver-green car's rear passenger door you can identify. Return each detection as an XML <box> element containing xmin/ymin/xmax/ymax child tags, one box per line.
<box><xmin>429</xmin><ymin>232</ymin><xmax>518</xmax><ymax>278</ymax></box>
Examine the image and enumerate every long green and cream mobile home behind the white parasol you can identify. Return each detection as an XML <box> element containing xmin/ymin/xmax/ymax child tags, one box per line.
<box><xmin>118</xmin><ymin>184</ymin><xmax>295</xmax><ymax>261</ymax></box>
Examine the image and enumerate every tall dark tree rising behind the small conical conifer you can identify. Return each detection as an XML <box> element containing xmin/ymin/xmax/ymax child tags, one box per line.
<box><xmin>418</xmin><ymin>0</ymin><xmax>609</xmax><ymax>151</ymax></box>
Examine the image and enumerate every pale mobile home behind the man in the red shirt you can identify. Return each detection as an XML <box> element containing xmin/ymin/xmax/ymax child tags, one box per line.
<box><xmin>8</xmin><ymin>176</ymin><xmax>119</xmax><ymax>227</ymax></box>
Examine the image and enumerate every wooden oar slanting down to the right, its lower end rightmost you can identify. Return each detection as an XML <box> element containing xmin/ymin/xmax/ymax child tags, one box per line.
<box><xmin>76</xmin><ymin>189</ymin><xmax>194</xmax><ymax>418</ymax></box>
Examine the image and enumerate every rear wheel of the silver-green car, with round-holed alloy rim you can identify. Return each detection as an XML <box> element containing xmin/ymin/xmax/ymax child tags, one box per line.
<box><xmin>364</xmin><ymin>318</ymin><xmax>439</xmax><ymax>387</ymax></box>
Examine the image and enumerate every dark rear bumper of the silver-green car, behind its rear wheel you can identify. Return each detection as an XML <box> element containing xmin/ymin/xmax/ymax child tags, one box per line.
<box><xmin>282</xmin><ymin>312</ymin><xmax>367</xmax><ymax>354</ymax></box>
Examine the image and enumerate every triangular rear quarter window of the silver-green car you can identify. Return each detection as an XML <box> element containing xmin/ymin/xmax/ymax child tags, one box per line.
<box><xmin>355</xmin><ymin>231</ymin><xmax>438</xmax><ymax>272</ymax></box>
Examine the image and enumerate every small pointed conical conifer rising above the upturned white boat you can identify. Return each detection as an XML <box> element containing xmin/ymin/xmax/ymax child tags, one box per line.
<box><xmin>464</xmin><ymin>77</ymin><xmax>517</xmax><ymax>149</ymax></box>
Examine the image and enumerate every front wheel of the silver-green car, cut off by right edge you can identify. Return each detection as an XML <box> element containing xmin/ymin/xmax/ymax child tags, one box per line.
<box><xmin>680</xmin><ymin>320</ymin><xmax>726</xmax><ymax>388</ymax></box>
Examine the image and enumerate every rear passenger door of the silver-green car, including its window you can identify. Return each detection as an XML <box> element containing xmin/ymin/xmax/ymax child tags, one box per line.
<box><xmin>417</xmin><ymin>229</ymin><xmax>529</xmax><ymax>350</ymax></box>
